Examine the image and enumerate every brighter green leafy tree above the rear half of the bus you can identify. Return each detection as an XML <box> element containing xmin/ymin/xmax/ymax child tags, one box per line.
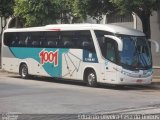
<box><xmin>14</xmin><ymin>0</ymin><xmax>85</xmax><ymax>27</ymax></box>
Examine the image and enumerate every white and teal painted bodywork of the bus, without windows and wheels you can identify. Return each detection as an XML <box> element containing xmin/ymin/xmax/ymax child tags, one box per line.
<box><xmin>2</xmin><ymin>24</ymin><xmax>152</xmax><ymax>85</ymax></box>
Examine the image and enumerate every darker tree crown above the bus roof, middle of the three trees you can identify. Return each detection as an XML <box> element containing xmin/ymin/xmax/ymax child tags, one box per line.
<box><xmin>73</xmin><ymin>0</ymin><xmax>115</xmax><ymax>23</ymax></box>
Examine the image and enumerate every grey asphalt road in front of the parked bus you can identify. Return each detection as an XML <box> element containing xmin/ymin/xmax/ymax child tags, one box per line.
<box><xmin>0</xmin><ymin>71</ymin><xmax>160</xmax><ymax>119</ymax></box>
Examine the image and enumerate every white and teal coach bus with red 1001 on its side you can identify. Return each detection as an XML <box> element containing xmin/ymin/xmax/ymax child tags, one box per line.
<box><xmin>2</xmin><ymin>24</ymin><xmax>157</xmax><ymax>87</ymax></box>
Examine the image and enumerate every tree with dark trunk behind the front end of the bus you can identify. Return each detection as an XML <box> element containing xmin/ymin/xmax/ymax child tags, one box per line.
<box><xmin>111</xmin><ymin>0</ymin><xmax>157</xmax><ymax>38</ymax></box>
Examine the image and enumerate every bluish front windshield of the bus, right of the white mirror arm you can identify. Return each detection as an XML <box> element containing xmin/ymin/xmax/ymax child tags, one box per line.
<box><xmin>119</xmin><ymin>35</ymin><xmax>152</xmax><ymax>69</ymax></box>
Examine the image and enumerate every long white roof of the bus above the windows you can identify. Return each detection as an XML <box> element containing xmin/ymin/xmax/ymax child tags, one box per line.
<box><xmin>5</xmin><ymin>24</ymin><xmax>145</xmax><ymax>36</ymax></box>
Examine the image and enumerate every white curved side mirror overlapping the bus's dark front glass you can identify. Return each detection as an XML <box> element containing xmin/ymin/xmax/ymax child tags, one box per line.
<box><xmin>104</xmin><ymin>35</ymin><xmax>123</xmax><ymax>51</ymax></box>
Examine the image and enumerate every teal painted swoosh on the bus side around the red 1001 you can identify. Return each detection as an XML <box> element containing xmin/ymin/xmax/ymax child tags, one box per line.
<box><xmin>10</xmin><ymin>47</ymin><xmax>69</xmax><ymax>77</ymax></box>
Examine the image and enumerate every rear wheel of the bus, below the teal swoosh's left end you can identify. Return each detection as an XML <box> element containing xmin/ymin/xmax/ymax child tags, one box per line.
<box><xmin>19</xmin><ymin>64</ymin><xmax>29</xmax><ymax>79</ymax></box>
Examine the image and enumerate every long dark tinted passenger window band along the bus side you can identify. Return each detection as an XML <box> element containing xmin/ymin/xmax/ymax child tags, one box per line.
<box><xmin>4</xmin><ymin>30</ymin><xmax>95</xmax><ymax>50</ymax></box>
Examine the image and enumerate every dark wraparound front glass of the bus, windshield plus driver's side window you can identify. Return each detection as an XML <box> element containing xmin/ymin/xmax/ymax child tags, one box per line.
<box><xmin>95</xmin><ymin>31</ymin><xmax>152</xmax><ymax>70</ymax></box>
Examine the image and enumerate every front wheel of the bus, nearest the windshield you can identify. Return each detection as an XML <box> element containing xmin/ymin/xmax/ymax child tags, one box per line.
<box><xmin>85</xmin><ymin>69</ymin><xmax>97</xmax><ymax>87</ymax></box>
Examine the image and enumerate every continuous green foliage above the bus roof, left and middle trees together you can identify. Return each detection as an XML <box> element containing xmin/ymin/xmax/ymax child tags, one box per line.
<box><xmin>14</xmin><ymin>0</ymin><xmax>113</xmax><ymax>26</ymax></box>
